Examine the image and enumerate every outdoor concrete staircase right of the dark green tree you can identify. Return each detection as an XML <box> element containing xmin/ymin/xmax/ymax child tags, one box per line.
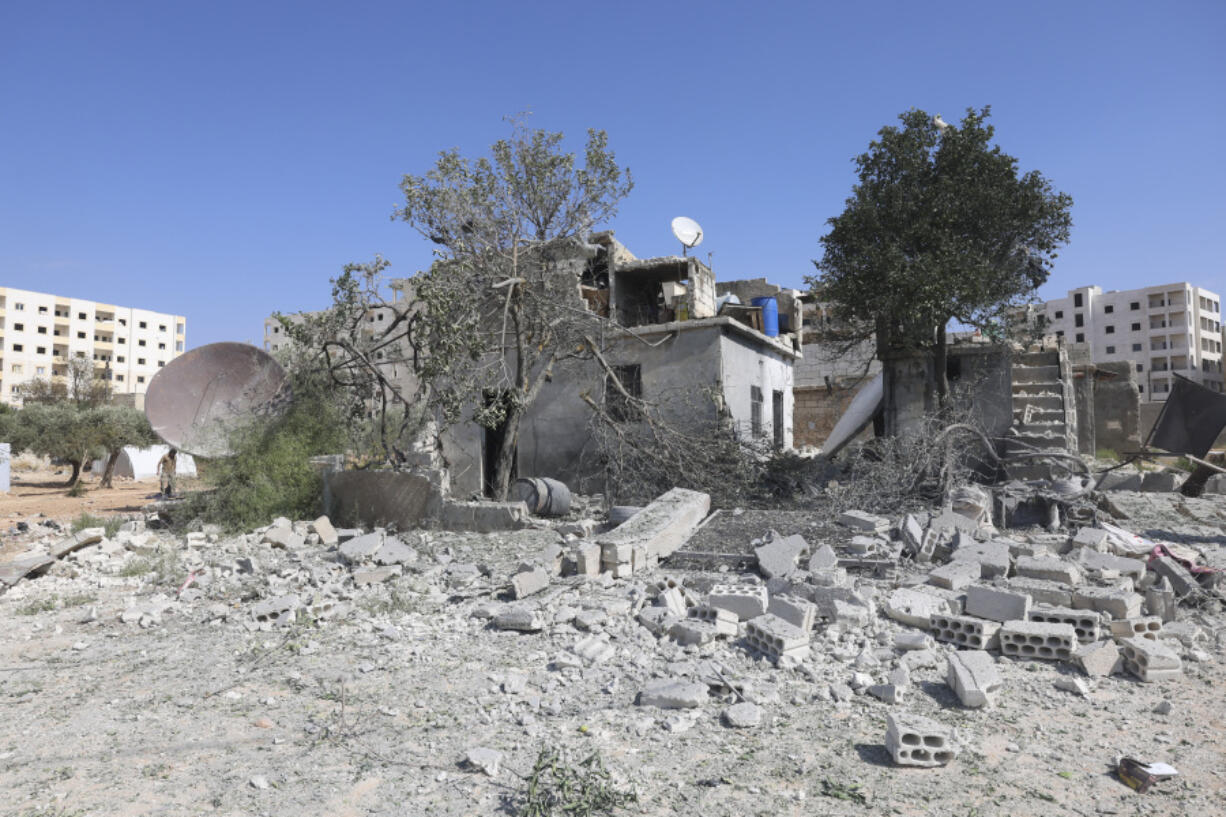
<box><xmin>1004</xmin><ymin>348</ymin><xmax>1076</xmax><ymax>480</ymax></box>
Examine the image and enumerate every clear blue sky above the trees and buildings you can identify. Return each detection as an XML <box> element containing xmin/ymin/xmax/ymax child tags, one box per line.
<box><xmin>0</xmin><ymin>0</ymin><xmax>1226</xmax><ymax>347</ymax></box>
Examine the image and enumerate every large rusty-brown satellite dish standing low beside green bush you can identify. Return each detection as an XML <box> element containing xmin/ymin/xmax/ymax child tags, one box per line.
<box><xmin>145</xmin><ymin>342</ymin><xmax>287</xmax><ymax>458</ymax></box>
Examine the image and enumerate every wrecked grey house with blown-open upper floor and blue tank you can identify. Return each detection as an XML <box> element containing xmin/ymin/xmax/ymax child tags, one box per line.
<box><xmin>265</xmin><ymin>231</ymin><xmax>802</xmax><ymax>497</ymax></box>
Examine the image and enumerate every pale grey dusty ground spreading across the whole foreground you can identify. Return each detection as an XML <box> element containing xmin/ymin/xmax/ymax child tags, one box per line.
<box><xmin>0</xmin><ymin>492</ymin><xmax>1226</xmax><ymax>817</ymax></box>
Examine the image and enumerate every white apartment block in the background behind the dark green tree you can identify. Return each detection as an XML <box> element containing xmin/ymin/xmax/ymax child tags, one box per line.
<box><xmin>1043</xmin><ymin>283</ymin><xmax>1226</xmax><ymax>402</ymax></box>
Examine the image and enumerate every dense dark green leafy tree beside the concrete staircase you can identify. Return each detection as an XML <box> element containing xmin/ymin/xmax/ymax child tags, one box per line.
<box><xmin>808</xmin><ymin>107</ymin><xmax>1073</xmax><ymax>401</ymax></box>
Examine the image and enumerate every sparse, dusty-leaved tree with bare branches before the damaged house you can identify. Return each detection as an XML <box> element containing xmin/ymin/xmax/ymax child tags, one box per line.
<box><xmin>396</xmin><ymin>123</ymin><xmax>633</xmax><ymax>498</ymax></box>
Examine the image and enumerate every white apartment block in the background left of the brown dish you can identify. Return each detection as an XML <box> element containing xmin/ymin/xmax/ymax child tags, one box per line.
<box><xmin>0</xmin><ymin>287</ymin><xmax>188</xmax><ymax>405</ymax></box>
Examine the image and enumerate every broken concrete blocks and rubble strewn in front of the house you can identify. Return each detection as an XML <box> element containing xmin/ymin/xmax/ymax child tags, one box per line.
<box><xmin>0</xmin><ymin>478</ymin><xmax>1226</xmax><ymax>813</ymax></box>
